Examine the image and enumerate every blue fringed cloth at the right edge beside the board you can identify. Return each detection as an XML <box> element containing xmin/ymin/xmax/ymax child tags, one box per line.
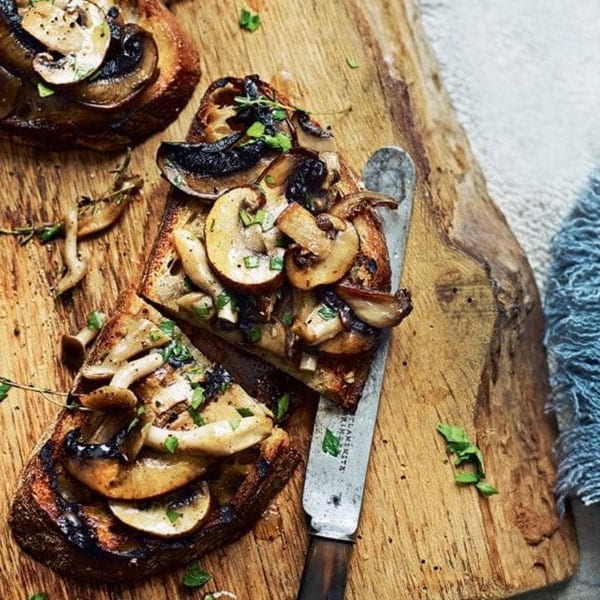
<box><xmin>544</xmin><ymin>170</ymin><xmax>600</xmax><ymax>513</ymax></box>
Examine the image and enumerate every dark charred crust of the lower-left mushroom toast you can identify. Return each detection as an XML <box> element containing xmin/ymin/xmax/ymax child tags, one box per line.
<box><xmin>9</xmin><ymin>293</ymin><xmax>300</xmax><ymax>582</ymax></box>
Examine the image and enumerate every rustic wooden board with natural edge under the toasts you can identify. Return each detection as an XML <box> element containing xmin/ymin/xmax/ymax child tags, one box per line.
<box><xmin>0</xmin><ymin>0</ymin><xmax>577</xmax><ymax>600</ymax></box>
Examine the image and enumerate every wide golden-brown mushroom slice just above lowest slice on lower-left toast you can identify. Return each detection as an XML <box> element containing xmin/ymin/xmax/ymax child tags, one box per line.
<box><xmin>66</xmin><ymin>448</ymin><xmax>214</xmax><ymax>500</ymax></box>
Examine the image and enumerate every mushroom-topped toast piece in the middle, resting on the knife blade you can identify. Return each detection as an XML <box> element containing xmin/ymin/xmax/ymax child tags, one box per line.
<box><xmin>140</xmin><ymin>76</ymin><xmax>411</xmax><ymax>409</ymax></box>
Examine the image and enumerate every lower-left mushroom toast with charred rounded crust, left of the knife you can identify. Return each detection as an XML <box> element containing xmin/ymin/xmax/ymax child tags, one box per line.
<box><xmin>9</xmin><ymin>293</ymin><xmax>299</xmax><ymax>582</ymax></box>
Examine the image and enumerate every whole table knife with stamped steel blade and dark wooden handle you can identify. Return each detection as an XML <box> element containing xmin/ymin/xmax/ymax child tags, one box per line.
<box><xmin>298</xmin><ymin>146</ymin><xmax>416</xmax><ymax>600</ymax></box>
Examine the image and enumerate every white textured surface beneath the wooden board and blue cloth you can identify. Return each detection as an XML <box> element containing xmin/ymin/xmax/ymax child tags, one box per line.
<box><xmin>417</xmin><ymin>0</ymin><xmax>600</xmax><ymax>600</ymax></box>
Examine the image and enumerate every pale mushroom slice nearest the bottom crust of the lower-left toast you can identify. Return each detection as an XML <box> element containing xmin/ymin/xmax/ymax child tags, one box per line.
<box><xmin>108</xmin><ymin>481</ymin><xmax>212</xmax><ymax>538</ymax></box>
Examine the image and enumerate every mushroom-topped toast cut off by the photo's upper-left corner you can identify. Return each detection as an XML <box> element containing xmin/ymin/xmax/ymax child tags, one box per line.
<box><xmin>0</xmin><ymin>0</ymin><xmax>200</xmax><ymax>150</ymax></box>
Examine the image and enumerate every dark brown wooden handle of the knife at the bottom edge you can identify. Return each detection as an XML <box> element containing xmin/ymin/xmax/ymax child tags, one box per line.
<box><xmin>298</xmin><ymin>536</ymin><xmax>352</xmax><ymax>600</ymax></box>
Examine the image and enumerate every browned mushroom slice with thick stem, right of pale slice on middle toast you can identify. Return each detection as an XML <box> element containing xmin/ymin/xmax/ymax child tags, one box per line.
<box><xmin>277</xmin><ymin>209</ymin><xmax>360</xmax><ymax>290</ymax></box>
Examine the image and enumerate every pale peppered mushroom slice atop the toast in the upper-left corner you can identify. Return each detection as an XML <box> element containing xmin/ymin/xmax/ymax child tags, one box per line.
<box><xmin>21</xmin><ymin>0</ymin><xmax>110</xmax><ymax>85</ymax></box>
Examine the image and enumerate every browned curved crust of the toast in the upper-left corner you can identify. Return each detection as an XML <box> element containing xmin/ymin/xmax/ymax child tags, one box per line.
<box><xmin>0</xmin><ymin>0</ymin><xmax>200</xmax><ymax>151</ymax></box>
